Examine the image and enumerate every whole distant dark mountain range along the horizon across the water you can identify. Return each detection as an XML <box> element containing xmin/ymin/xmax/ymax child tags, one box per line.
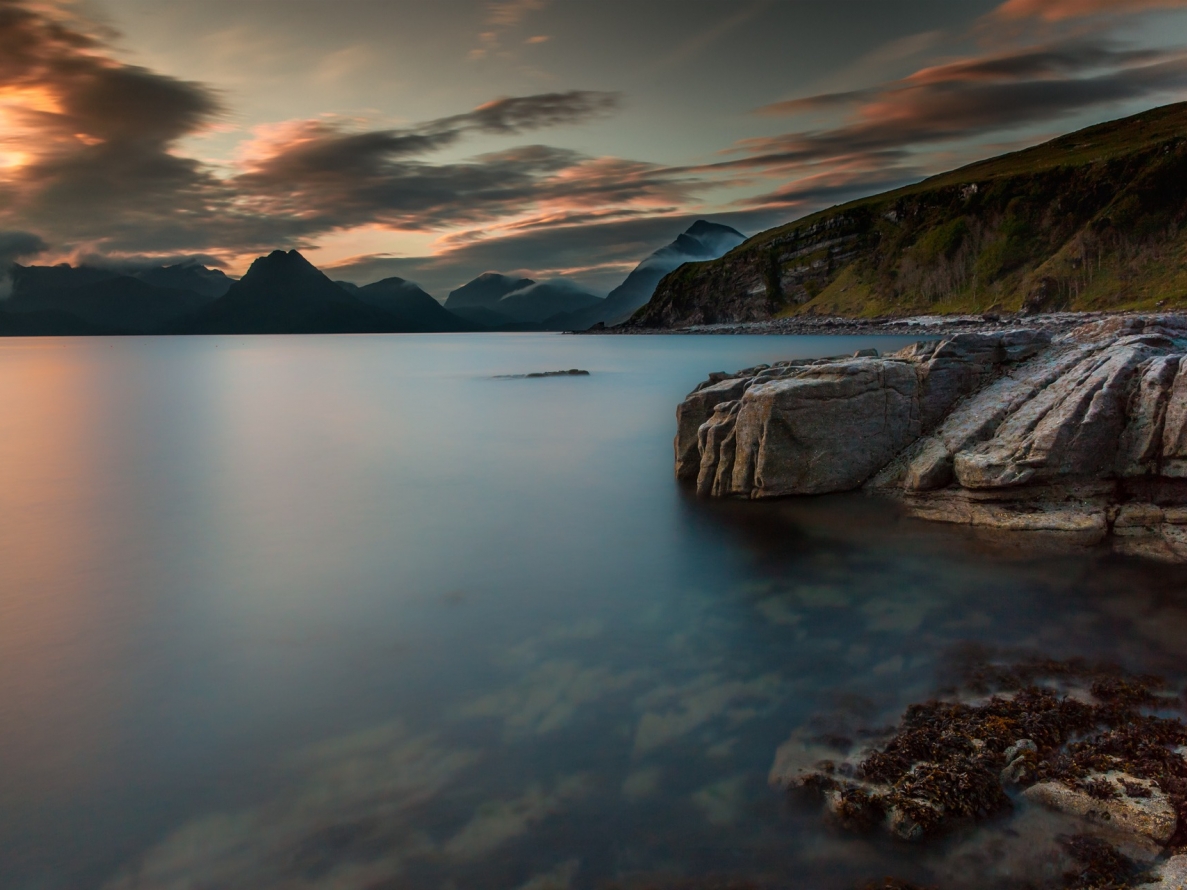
<box><xmin>0</xmin><ymin>221</ymin><xmax>744</xmax><ymax>336</ymax></box>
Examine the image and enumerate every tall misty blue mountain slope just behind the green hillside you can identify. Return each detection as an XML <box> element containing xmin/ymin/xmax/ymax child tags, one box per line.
<box><xmin>552</xmin><ymin>220</ymin><xmax>745</xmax><ymax>331</ymax></box>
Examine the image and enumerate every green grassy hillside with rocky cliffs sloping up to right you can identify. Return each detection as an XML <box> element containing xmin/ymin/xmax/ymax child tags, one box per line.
<box><xmin>627</xmin><ymin>103</ymin><xmax>1187</xmax><ymax>328</ymax></box>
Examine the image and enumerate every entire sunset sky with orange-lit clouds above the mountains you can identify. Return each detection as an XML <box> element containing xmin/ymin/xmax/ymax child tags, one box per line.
<box><xmin>0</xmin><ymin>0</ymin><xmax>1187</xmax><ymax>298</ymax></box>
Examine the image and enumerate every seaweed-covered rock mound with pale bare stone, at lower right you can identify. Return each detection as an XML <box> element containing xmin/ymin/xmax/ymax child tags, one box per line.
<box><xmin>770</xmin><ymin>662</ymin><xmax>1187</xmax><ymax>859</ymax></box>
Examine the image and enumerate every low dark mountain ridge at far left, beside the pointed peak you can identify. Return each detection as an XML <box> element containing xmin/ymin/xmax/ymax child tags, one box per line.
<box><xmin>4</xmin><ymin>266</ymin><xmax>218</xmax><ymax>335</ymax></box>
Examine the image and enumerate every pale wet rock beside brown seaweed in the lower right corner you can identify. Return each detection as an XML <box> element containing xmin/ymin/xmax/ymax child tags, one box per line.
<box><xmin>1022</xmin><ymin>770</ymin><xmax>1178</xmax><ymax>847</ymax></box>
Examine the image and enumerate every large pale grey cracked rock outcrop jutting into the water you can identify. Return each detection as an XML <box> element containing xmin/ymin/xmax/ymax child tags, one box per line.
<box><xmin>675</xmin><ymin>316</ymin><xmax>1187</xmax><ymax>560</ymax></box>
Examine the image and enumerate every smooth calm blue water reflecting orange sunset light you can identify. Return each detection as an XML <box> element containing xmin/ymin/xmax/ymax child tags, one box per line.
<box><xmin>0</xmin><ymin>335</ymin><xmax>1187</xmax><ymax>890</ymax></box>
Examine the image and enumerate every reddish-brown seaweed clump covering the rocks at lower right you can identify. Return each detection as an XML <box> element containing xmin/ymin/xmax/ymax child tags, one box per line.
<box><xmin>799</xmin><ymin>660</ymin><xmax>1187</xmax><ymax>850</ymax></box>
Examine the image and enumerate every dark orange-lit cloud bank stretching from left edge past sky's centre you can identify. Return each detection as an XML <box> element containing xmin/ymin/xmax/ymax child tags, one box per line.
<box><xmin>0</xmin><ymin>0</ymin><xmax>631</xmax><ymax>261</ymax></box>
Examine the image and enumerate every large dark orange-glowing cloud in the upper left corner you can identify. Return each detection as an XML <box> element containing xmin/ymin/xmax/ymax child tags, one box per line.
<box><xmin>0</xmin><ymin>0</ymin><xmax>220</xmax><ymax>253</ymax></box>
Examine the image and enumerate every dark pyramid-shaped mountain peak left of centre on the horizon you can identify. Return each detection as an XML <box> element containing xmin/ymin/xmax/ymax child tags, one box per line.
<box><xmin>171</xmin><ymin>250</ymin><xmax>413</xmax><ymax>333</ymax></box>
